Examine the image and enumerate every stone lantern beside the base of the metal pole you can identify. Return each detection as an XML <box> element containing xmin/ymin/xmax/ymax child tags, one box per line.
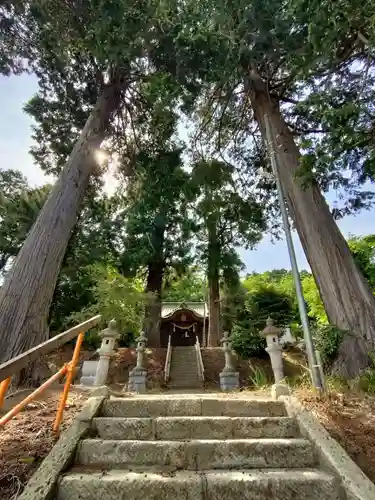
<box><xmin>261</xmin><ymin>318</ymin><xmax>290</xmax><ymax>399</ymax></box>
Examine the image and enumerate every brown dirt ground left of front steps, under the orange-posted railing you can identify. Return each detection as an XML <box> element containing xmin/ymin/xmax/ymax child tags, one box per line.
<box><xmin>0</xmin><ymin>392</ymin><xmax>87</xmax><ymax>500</ymax></box>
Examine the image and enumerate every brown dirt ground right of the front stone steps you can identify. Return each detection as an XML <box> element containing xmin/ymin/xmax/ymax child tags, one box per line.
<box><xmin>295</xmin><ymin>389</ymin><xmax>375</xmax><ymax>483</ymax></box>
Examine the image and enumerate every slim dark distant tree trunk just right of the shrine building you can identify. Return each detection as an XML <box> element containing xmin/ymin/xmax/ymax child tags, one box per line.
<box><xmin>207</xmin><ymin>215</ymin><xmax>220</xmax><ymax>347</ymax></box>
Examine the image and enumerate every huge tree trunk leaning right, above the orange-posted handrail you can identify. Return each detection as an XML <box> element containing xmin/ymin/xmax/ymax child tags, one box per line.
<box><xmin>0</xmin><ymin>85</ymin><xmax>120</xmax><ymax>380</ymax></box>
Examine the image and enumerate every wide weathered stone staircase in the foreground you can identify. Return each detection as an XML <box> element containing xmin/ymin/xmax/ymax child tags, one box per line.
<box><xmin>56</xmin><ymin>395</ymin><xmax>340</xmax><ymax>500</ymax></box>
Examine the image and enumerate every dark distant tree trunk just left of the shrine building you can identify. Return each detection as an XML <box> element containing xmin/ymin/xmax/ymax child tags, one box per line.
<box><xmin>143</xmin><ymin>217</ymin><xmax>165</xmax><ymax>347</ymax></box>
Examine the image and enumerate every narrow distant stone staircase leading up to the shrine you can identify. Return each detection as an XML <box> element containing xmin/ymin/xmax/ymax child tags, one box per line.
<box><xmin>168</xmin><ymin>346</ymin><xmax>202</xmax><ymax>389</ymax></box>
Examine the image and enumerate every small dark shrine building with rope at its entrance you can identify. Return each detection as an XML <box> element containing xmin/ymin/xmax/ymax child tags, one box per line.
<box><xmin>160</xmin><ymin>303</ymin><xmax>208</xmax><ymax>347</ymax></box>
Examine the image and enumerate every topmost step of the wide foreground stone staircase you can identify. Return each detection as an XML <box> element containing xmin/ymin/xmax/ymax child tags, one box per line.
<box><xmin>100</xmin><ymin>397</ymin><xmax>287</xmax><ymax>417</ymax></box>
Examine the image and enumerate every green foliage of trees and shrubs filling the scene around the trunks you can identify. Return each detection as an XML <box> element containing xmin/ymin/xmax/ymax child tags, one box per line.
<box><xmin>4</xmin><ymin>0</ymin><xmax>375</xmax><ymax>368</ymax></box>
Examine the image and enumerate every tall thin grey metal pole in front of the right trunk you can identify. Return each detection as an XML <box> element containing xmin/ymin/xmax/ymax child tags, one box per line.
<box><xmin>264</xmin><ymin>115</ymin><xmax>322</xmax><ymax>391</ymax></box>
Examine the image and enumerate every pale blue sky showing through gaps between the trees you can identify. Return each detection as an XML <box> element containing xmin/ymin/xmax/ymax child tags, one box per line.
<box><xmin>0</xmin><ymin>75</ymin><xmax>375</xmax><ymax>272</ymax></box>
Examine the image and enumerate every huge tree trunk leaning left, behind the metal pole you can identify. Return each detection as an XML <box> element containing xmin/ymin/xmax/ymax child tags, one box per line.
<box><xmin>249</xmin><ymin>79</ymin><xmax>375</xmax><ymax>377</ymax></box>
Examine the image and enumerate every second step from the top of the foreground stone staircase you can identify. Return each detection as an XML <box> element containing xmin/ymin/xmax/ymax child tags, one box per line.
<box><xmin>93</xmin><ymin>417</ymin><xmax>299</xmax><ymax>440</ymax></box>
